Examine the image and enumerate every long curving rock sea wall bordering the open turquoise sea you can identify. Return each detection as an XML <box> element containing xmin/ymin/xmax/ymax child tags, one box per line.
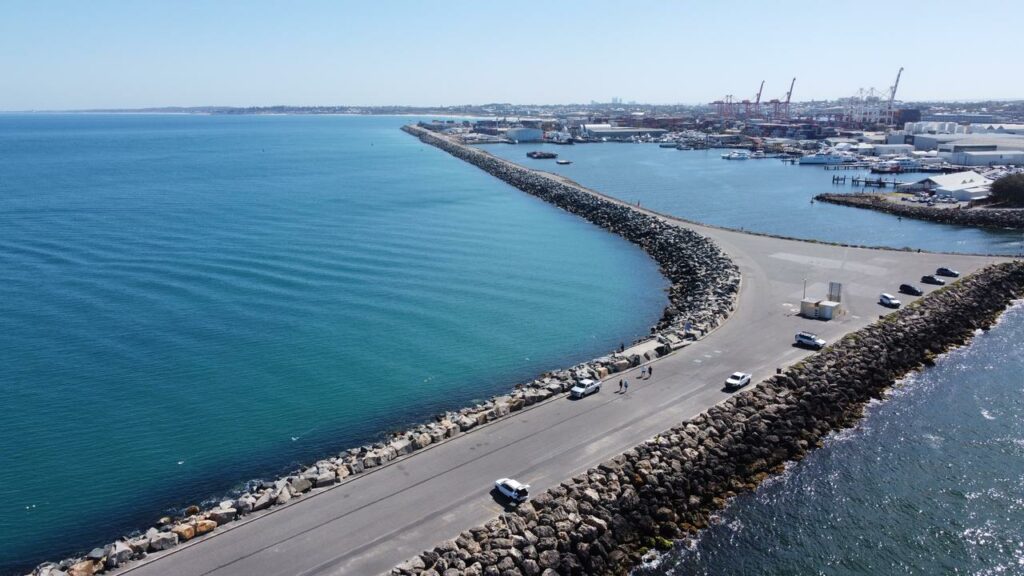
<box><xmin>22</xmin><ymin>127</ymin><xmax>739</xmax><ymax>576</ymax></box>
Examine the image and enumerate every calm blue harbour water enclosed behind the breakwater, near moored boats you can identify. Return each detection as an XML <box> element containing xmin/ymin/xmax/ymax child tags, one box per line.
<box><xmin>481</xmin><ymin>142</ymin><xmax>1024</xmax><ymax>254</ymax></box>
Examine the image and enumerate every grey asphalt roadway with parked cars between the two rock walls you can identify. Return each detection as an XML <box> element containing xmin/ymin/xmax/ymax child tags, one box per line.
<box><xmin>117</xmin><ymin>174</ymin><xmax>1001</xmax><ymax>576</ymax></box>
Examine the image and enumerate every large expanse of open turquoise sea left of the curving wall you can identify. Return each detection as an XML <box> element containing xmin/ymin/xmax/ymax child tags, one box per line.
<box><xmin>0</xmin><ymin>115</ymin><xmax>667</xmax><ymax>573</ymax></box>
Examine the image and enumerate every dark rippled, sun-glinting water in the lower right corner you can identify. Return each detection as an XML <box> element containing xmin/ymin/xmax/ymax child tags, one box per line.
<box><xmin>636</xmin><ymin>304</ymin><xmax>1024</xmax><ymax>576</ymax></box>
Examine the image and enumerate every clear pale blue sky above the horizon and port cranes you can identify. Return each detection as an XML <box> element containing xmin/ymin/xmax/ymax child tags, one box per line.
<box><xmin>0</xmin><ymin>0</ymin><xmax>1024</xmax><ymax>111</ymax></box>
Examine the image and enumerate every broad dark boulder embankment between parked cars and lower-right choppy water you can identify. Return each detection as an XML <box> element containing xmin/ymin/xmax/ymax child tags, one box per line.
<box><xmin>392</xmin><ymin>261</ymin><xmax>1024</xmax><ymax>576</ymax></box>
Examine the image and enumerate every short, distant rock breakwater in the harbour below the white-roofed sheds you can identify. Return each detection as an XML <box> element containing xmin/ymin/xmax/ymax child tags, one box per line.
<box><xmin>814</xmin><ymin>194</ymin><xmax>1024</xmax><ymax>230</ymax></box>
